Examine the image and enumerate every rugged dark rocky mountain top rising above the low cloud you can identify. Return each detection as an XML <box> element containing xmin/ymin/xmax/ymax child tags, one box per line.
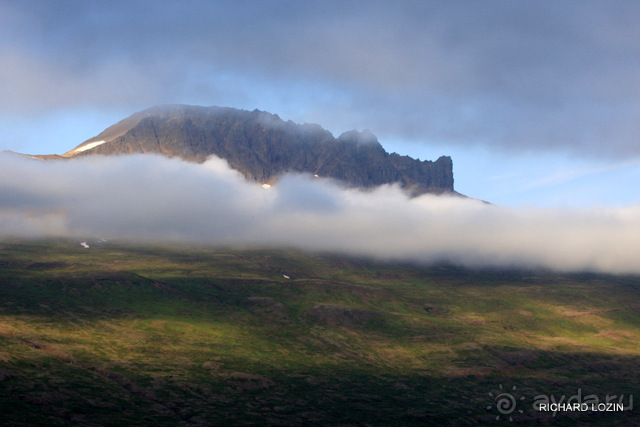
<box><xmin>62</xmin><ymin>105</ymin><xmax>454</xmax><ymax>195</ymax></box>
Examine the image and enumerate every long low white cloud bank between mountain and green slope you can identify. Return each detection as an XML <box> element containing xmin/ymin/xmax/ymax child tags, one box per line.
<box><xmin>0</xmin><ymin>155</ymin><xmax>640</xmax><ymax>273</ymax></box>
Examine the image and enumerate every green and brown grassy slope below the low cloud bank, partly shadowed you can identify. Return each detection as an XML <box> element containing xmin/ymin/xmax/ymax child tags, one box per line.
<box><xmin>0</xmin><ymin>241</ymin><xmax>640</xmax><ymax>425</ymax></box>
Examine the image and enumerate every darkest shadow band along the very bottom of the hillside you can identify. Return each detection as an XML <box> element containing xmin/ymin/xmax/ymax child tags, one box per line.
<box><xmin>0</xmin><ymin>343</ymin><xmax>640</xmax><ymax>425</ymax></box>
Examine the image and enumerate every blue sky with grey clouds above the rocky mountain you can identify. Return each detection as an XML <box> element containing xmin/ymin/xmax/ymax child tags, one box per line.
<box><xmin>0</xmin><ymin>0</ymin><xmax>640</xmax><ymax>207</ymax></box>
